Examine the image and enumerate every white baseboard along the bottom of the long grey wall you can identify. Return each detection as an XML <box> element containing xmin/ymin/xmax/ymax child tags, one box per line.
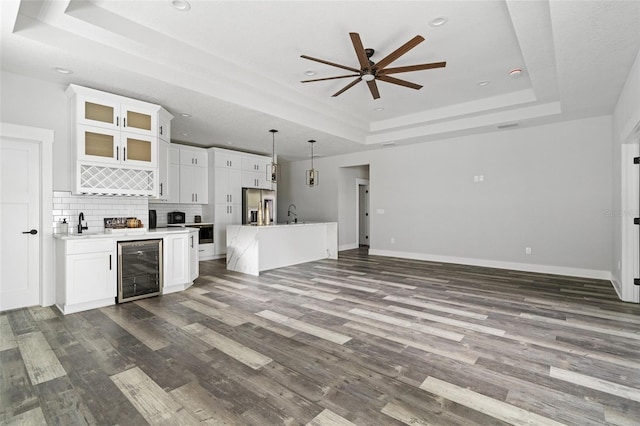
<box><xmin>369</xmin><ymin>249</ymin><xmax>617</xmax><ymax>282</ymax></box>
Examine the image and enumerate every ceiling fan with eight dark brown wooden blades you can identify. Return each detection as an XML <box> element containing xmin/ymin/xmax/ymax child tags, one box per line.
<box><xmin>300</xmin><ymin>33</ymin><xmax>447</xmax><ymax>99</ymax></box>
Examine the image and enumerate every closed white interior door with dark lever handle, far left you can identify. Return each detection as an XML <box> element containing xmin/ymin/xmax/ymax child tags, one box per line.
<box><xmin>0</xmin><ymin>136</ymin><xmax>42</xmax><ymax>310</ymax></box>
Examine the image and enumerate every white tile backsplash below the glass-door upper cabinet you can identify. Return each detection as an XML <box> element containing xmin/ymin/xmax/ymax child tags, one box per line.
<box><xmin>52</xmin><ymin>191</ymin><xmax>150</xmax><ymax>234</ymax></box>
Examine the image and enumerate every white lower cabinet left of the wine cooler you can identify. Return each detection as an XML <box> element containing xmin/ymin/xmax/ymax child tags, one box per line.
<box><xmin>55</xmin><ymin>239</ymin><xmax>117</xmax><ymax>314</ymax></box>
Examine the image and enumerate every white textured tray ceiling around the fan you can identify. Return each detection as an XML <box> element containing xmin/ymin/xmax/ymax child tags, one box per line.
<box><xmin>0</xmin><ymin>0</ymin><xmax>640</xmax><ymax>159</ymax></box>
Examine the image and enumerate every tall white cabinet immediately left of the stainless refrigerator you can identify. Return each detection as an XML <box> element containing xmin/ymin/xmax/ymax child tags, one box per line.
<box><xmin>209</xmin><ymin>148</ymin><xmax>242</xmax><ymax>256</ymax></box>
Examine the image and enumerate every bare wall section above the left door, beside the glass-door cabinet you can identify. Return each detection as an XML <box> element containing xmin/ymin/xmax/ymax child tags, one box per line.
<box><xmin>0</xmin><ymin>71</ymin><xmax>73</xmax><ymax>191</ymax></box>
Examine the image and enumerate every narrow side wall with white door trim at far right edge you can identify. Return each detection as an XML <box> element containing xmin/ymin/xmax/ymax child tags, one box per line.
<box><xmin>611</xmin><ymin>46</ymin><xmax>640</xmax><ymax>302</ymax></box>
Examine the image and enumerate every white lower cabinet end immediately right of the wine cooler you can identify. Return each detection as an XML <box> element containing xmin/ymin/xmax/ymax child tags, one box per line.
<box><xmin>162</xmin><ymin>233</ymin><xmax>191</xmax><ymax>294</ymax></box>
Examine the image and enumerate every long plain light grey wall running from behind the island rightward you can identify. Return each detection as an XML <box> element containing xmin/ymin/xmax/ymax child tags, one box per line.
<box><xmin>278</xmin><ymin>116</ymin><xmax>612</xmax><ymax>278</ymax></box>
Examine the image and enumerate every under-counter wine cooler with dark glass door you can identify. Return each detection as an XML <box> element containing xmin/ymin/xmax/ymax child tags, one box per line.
<box><xmin>117</xmin><ymin>239</ymin><xmax>163</xmax><ymax>303</ymax></box>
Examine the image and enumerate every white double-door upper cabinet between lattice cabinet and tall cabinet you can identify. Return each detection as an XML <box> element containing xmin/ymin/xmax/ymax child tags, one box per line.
<box><xmin>179</xmin><ymin>147</ymin><xmax>209</xmax><ymax>204</ymax></box>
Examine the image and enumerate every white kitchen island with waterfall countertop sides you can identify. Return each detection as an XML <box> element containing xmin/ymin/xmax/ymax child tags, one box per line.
<box><xmin>227</xmin><ymin>222</ymin><xmax>338</xmax><ymax>276</ymax></box>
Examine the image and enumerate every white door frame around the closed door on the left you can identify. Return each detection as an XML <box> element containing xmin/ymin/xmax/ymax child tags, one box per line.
<box><xmin>0</xmin><ymin>122</ymin><xmax>55</xmax><ymax>306</ymax></box>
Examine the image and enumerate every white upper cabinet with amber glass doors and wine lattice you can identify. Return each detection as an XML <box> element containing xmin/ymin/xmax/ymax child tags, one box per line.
<box><xmin>66</xmin><ymin>84</ymin><xmax>160</xmax><ymax>196</ymax></box>
